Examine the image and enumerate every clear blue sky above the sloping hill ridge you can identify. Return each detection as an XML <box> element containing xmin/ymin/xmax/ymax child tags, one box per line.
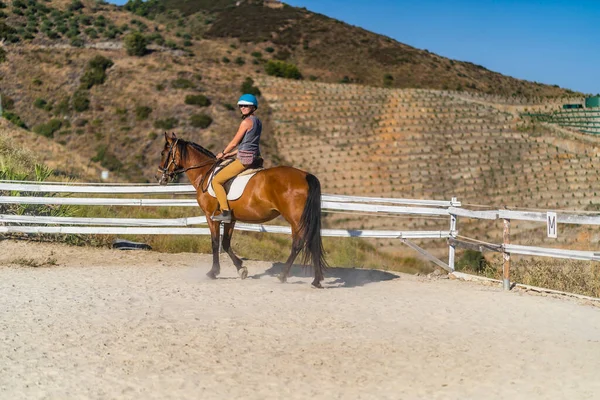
<box><xmin>105</xmin><ymin>0</ymin><xmax>600</xmax><ymax>94</ymax></box>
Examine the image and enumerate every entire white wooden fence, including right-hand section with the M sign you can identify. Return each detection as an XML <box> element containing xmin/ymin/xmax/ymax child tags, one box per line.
<box><xmin>0</xmin><ymin>181</ymin><xmax>600</xmax><ymax>289</ymax></box>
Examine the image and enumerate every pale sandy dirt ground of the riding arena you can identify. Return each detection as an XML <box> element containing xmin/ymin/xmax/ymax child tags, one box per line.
<box><xmin>0</xmin><ymin>241</ymin><xmax>600</xmax><ymax>400</ymax></box>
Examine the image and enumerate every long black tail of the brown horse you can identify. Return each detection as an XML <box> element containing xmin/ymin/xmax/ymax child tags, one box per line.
<box><xmin>300</xmin><ymin>174</ymin><xmax>328</xmax><ymax>282</ymax></box>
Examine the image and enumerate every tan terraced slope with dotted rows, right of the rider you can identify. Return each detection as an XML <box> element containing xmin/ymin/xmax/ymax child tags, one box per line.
<box><xmin>260</xmin><ymin>78</ymin><xmax>600</xmax><ymax>253</ymax></box>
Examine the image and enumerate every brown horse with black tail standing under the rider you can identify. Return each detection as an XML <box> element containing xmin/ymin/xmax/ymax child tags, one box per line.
<box><xmin>158</xmin><ymin>133</ymin><xmax>327</xmax><ymax>288</ymax></box>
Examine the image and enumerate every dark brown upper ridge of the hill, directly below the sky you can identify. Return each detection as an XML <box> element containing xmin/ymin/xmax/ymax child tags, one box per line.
<box><xmin>128</xmin><ymin>0</ymin><xmax>573</xmax><ymax>97</ymax></box>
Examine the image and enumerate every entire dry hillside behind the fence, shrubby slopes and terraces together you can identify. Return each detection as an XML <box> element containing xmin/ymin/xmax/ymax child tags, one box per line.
<box><xmin>0</xmin><ymin>0</ymin><xmax>596</xmax><ymax>207</ymax></box>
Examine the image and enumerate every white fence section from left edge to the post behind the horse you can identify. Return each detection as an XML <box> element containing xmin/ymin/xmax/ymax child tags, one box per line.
<box><xmin>0</xmin><ymin>181</ymin><xmax>460</xmax><ymax>271</ymax></box>
